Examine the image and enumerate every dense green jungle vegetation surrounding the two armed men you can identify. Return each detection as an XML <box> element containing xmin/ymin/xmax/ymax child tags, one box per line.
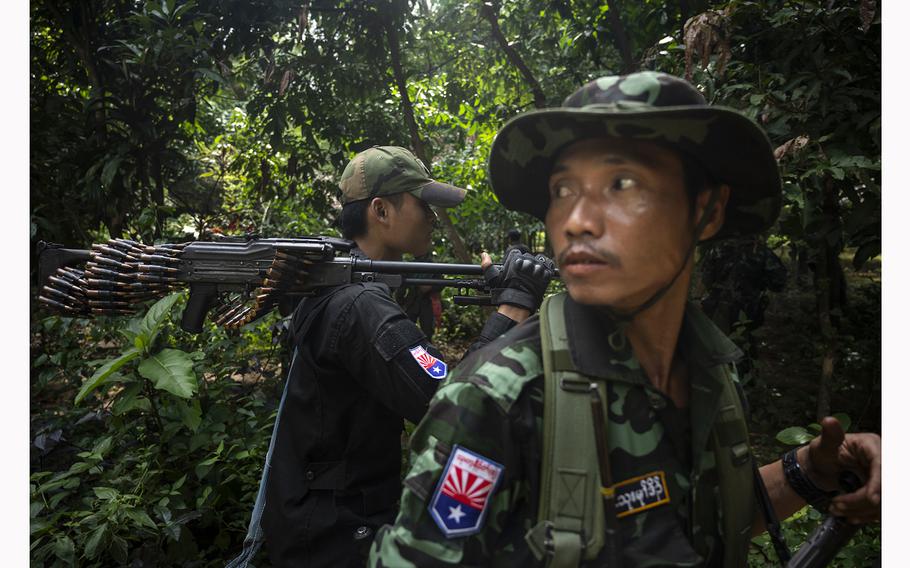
<box><xmin>30</xmin><ymin>0</ymin><xmax>881</xmax><ymax>566</ymax></box>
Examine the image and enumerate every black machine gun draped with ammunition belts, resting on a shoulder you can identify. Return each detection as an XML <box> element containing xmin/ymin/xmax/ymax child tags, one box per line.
<box><xmin>38</xmin><ymin>237</ymin><xmax>528</xmax><ymax>333</ymax></box>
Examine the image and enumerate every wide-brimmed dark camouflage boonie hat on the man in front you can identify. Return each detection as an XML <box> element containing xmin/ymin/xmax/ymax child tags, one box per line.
<box><xmin>489</xmin><ymin>71</ymin><xmax>781</xmax><ymax>240</ymax></box>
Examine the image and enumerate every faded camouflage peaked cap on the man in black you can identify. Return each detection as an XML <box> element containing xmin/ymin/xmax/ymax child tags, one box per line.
<box><xmin>339</xmin><ymin>146</ymin><xmax>467</xmax><ymax>207</ymax></box>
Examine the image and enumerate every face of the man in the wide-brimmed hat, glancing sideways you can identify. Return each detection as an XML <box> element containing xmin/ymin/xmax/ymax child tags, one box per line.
<box><xmin>546</xmin><ymin>138</ymin><xmax>694</xmax><ymax>311</ymax></box>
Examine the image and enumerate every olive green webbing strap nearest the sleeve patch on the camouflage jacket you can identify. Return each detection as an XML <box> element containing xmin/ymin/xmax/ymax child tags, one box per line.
<box><xmin>525</xmin><ymin>293</ymin><xmax>607</xmax><ymax>568</ymax></box>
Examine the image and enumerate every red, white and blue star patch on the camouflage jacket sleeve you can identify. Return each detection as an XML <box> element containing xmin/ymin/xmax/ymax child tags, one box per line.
<box><xmin>429</xmin><ymin>444</ymin><xmax>505</xmax><ymax>538</ymax></box>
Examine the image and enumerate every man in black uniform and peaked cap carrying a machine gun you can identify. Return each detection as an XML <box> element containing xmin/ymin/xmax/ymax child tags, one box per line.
<box><xmin>229</xmin><ymin>146</ymin><xmax>552</xmax><ymax>567</ymax></box>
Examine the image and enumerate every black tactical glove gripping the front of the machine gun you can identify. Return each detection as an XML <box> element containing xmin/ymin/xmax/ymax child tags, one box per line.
<box><xmin>483</xmin><ymin>248</ymin><xmax>556</xmax><ymax>312</ymax></box>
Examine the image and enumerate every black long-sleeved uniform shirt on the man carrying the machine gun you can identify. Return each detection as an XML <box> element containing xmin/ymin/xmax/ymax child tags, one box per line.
<box><xmin>262</xmin><ymin>258</ymin><xmax>514</xmax><ymax>566</ymax></box>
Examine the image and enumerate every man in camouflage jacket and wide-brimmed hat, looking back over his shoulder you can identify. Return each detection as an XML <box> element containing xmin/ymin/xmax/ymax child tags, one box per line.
<box><xmin>370</xmin><ymin>72</ymin><xmax>881</xmax><ymax>567</ymax></box>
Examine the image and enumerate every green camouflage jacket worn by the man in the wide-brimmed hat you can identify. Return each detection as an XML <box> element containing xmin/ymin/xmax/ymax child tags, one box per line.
<box><xmin>370</xmin><ymin>300</ymin><xmax>741</xmax><ymax>567</ymax></box>
